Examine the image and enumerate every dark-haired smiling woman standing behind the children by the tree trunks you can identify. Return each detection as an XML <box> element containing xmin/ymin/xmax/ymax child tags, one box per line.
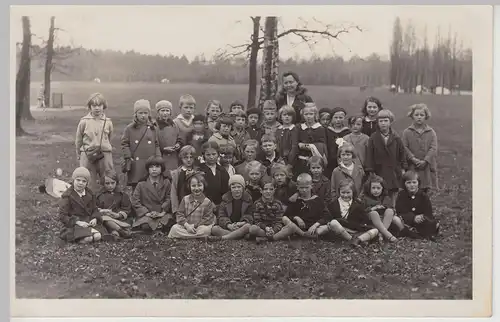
<box><xmin>276</xmin><ymin>72</ymin><xmax>313</xmax><ymax>124</ymax></box>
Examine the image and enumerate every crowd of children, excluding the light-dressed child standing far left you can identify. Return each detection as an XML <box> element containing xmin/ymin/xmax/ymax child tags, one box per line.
<box><xmin>60</xmin><ymin>95</ymin><xmax>439</xmax><ymax>246</ymax></box>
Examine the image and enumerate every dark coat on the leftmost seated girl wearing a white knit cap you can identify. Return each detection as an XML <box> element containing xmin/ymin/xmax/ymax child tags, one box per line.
<box><xmin>59</xmin><ymin>186</ymin><xmax>108</xmax><ymax>242</ymax></box>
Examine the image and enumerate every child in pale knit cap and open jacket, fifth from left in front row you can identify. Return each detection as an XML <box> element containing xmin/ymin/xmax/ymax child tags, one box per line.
<box><xmin>209</xmin><ymin>174</ymin><xmax>254</xmax><ymax>241</ymax></box>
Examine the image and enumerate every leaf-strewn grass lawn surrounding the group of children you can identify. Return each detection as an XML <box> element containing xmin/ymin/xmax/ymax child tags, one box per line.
<box><xmin>15</xmin><ymin>83</ymin><xmax>472</xmax><ymax>299</ymax></box>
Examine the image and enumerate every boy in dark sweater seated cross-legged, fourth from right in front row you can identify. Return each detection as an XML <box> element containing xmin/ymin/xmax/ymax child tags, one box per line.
<box><xmin>283</xmin><ymin>173</ymin><xmax>330</xmax><ymax>238</ymax></box>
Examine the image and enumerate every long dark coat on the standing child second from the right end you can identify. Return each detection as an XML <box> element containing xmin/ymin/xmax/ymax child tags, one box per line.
<box><xmin>366</xmin><ymin>130</ymin><xmax>408</xmax><ymax>190</ymax></box>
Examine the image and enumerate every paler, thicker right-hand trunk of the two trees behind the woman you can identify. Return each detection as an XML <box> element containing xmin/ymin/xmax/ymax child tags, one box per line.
<box><xmin>259</xmin><ymin>17</ymin><xmax>279</xmax><ymax>109</ymax></box>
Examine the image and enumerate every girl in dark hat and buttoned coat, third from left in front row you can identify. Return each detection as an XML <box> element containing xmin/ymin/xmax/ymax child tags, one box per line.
<box><xmin>132</xmin><ymin>156</ymin><xmax>173</xmax><ymax>233</ymax></box>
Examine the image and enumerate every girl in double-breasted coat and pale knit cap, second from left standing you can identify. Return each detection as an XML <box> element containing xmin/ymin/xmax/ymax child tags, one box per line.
<box><xmin>121</xmin><ymin>99</ymin><xmax>161</xmax><ymax>189</ymax></box>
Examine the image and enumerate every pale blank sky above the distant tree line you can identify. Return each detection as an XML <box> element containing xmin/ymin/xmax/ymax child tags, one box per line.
<box><xmin>10</xmin><ymin>5</ymin><xmax>477</xmax><ymax>60</ymax></box>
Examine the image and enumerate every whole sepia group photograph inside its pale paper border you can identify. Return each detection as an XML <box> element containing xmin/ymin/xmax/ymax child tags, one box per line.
<box><xmin>10</xmin><ymin>5</ymin><xmax>488</xmax><ymax>314</ymax></box>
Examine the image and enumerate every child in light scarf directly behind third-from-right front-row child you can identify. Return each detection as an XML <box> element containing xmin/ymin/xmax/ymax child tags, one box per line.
<box><xmin>331</xmin><ymin>142</ymin><xmax>365</xmax><ymax>199</ymax></box>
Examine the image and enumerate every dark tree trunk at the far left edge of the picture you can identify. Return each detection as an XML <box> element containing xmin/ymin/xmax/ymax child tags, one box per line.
<box><xmin>16</xmin><ymin>16</ymin><xmax>31</xmax><ymax>136</ymax></box>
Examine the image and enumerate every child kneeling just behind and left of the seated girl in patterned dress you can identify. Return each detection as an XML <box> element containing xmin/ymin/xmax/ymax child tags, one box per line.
<box><xmin>170</xmin><ymin>145</ymin><xmax>196</xmax><ymax>213</ymax></box>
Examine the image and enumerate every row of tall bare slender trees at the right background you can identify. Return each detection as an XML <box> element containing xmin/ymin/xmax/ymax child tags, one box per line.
<box><xmin>390</xmin><ymin>18</ymin><xmax>472</xmax><ymax>93</ymax></box>
